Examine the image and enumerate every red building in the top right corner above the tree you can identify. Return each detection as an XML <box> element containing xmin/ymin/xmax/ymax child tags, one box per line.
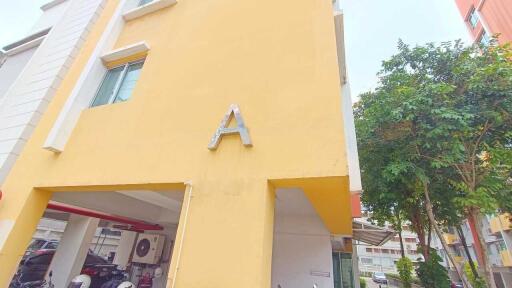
<box><xmin>455</xmin><ymin>0</ymin><xmax>512</xmax><ymax>43</ymax></box>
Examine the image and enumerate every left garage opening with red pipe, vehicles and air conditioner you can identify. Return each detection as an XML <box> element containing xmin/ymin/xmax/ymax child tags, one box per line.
<box><xmin>11</xmin><ymin>190</ymin><xmax>184</xmax><ymax>288</ymax></box>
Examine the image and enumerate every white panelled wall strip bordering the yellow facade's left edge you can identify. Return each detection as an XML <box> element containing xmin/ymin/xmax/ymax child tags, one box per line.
<box><xmin>0</xmin><ymin>0</ymin><xmax>105</xmax><ymax>184</ymax></box>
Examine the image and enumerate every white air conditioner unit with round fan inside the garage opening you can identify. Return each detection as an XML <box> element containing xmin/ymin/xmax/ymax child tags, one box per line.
<box><xmin>132</xmin><ymin>234</ymin><xmax>165</xmax><ymax>264</ymax></box>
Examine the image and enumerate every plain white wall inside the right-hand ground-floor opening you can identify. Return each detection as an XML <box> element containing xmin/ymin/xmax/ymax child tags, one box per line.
<box><xmin>272</xmin><ymin>191</ymin><xmax>334</xmax><ymax>288</ymax></box>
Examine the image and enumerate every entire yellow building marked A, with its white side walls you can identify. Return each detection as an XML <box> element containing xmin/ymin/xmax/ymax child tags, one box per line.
<box><xmin>0</xmin><ymin>0</ymin><xmax>364</xmax><ymax>288</ymax></box>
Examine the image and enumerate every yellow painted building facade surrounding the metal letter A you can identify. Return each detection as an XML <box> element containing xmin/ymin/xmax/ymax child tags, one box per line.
<box><xmin>0</xmin><ymin>0</ymin><xmax>360</xmax><ymax>288</ymax></box>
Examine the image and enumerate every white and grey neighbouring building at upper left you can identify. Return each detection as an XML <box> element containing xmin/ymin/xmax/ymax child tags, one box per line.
<box><xmin>0</xmin><ymin>0</ymin><xmax>104</xmax><ymax>184</ymax></box>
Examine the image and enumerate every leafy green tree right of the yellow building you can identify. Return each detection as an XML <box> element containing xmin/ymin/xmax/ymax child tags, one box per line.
<box><xmin>355</xmin><ymin>41</ymin><xmax>512</xmax><ymax>287</ymax></box>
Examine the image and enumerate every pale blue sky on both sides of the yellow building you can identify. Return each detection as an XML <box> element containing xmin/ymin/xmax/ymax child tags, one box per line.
<box><xmin>0</xmin><ymin>0</ymin><xmax>470</xmax><ymax>100</ymax></box>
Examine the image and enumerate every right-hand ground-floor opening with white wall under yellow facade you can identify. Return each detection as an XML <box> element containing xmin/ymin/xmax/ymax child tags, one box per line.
<box><xmin>272</xmin><ymin>189</ymin><xmax>354</xmax><ymax>288</ymax></box>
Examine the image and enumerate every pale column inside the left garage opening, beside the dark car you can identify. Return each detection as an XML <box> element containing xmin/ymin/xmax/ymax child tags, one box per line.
<box><xmin>48</xmin><ymin>215</ymin><xmax>100</xmax><ymax>287</ymax></box>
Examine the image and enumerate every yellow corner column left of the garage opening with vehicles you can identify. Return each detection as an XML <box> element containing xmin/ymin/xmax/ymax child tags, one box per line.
<box><xmin>0</xmin><ymin>188</ymin><xmax>51</xmax><ymax>287</ymax></box>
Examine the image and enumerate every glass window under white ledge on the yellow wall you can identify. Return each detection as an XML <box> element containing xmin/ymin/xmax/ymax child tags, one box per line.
<box><xmin>91</xmin><ymin>60</ymin><xmax>144</xmax><ymax>107</ymax></box>
